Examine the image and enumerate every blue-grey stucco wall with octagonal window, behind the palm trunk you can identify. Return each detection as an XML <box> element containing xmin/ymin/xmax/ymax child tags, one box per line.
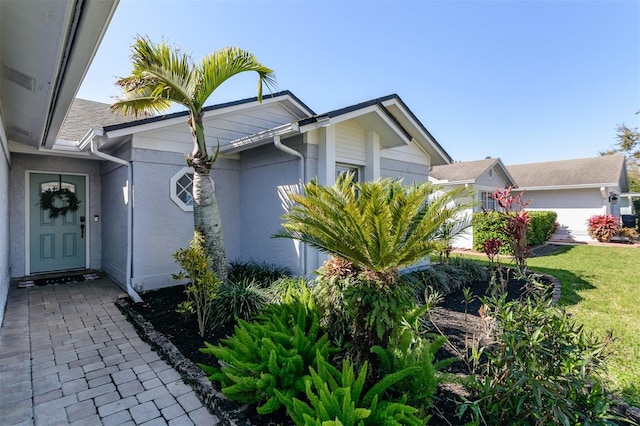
<box><xmin>127</xmin><ymin>149</ymin><xmax>239</xmax><ymax>291</ymax></box>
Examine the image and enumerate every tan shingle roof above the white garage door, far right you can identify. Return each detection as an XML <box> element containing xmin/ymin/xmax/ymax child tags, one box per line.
<box><xmin>507</xmin><ymin>154</ymin><xmax>628</xmax><ymax>191</ymax></box>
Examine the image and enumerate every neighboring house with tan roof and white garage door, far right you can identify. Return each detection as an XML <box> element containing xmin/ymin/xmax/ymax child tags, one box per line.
<box><xmin>507</xmin><ymin>154</ymin><xmax>633</xmax><ymax>241</ymax></box>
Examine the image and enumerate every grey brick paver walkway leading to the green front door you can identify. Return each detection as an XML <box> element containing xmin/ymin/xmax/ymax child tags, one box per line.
<box><xmin>0</xmin><ymin>278</ymin><xmax>219</xmax><ymax>426</ymax></box>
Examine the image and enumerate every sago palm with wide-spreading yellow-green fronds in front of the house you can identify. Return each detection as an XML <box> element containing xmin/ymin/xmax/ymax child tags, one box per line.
<box><xmin>276</xmin><ymin>174</ymin><xmax>473</xmax><ymax>280</ymax></box>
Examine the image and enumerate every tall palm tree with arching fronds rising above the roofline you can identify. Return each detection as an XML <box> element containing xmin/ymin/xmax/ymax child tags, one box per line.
<box><xmin>111</xmin><ymin>37</ymin><xmax>275</xmax><ymax>280</ymax></box>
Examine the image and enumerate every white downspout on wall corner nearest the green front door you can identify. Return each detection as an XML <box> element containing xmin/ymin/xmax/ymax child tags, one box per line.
<box><xmin>78</xmin><ymin>129</ymin><xmax>142</xmax><ymax>303</ymax></box>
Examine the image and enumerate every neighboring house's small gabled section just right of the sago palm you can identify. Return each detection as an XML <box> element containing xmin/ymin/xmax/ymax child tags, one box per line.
<box><xmin>429</xmin><ymin>158</ymin><xmax>516</xmax><ymax>249</ymax></box>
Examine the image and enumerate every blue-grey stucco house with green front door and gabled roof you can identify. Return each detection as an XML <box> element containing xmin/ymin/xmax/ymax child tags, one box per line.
<box><xmin>9</xmin><ymin>91</ymin><xmax>451</xmax><ymax>298</ymax></box>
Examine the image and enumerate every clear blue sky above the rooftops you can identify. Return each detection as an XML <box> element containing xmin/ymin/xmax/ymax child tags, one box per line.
<box><xmin>78</xmin><ymin>0</ymin><xmax>640</xmax><ymax>164</ymax></box>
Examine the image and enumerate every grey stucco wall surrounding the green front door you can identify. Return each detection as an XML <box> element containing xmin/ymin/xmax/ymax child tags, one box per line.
<box><xmin>9</xmin><ymin>154</ymin><xmax>102</xmax><ymax>277</ymax></box>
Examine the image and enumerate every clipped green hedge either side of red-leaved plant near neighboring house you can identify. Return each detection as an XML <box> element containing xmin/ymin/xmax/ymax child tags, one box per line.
<box><xmin>471</xmin><ymin>211</ymin><xmax>557</xmax><ymax>254</ymax></box>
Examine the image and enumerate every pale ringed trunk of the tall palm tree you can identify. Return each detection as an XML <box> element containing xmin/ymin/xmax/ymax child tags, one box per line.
<box><xmin>193</xmin><ymin>159</ymin><xmax>227</xmax><ymax>281</ymax></box>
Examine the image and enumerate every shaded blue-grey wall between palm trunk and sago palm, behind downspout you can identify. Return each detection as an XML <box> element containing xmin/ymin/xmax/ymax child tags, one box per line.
<box><xmin>239</xmin><ymin>141</ymin><xmax>301</xmax><ymax>273</ymax></box>
